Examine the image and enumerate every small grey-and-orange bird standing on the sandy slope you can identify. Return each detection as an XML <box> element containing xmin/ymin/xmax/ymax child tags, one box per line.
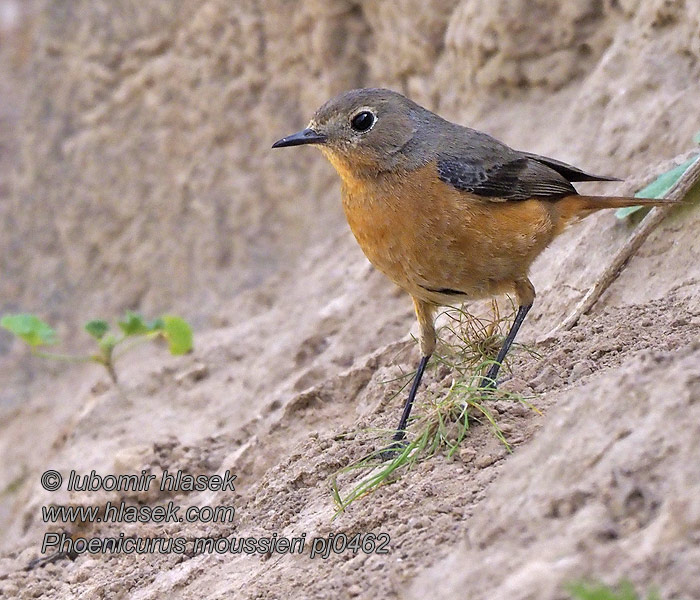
<box><xmin>272</xmin><ymin>89</ymin><xmax>663</xmax><ymax>444</ymax></box>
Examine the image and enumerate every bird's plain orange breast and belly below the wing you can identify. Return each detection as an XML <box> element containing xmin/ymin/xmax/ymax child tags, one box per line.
<box><xmin>338</xmin><ymin>165</ymin><xmax>554</xmax><ymax>304</ymax></box>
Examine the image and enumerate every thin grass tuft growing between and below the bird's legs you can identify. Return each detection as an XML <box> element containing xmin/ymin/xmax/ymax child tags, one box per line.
<box><xmin>330</xmin><ymin>302</ymin><xmax>537</xmax><ymax>515</ymax></box>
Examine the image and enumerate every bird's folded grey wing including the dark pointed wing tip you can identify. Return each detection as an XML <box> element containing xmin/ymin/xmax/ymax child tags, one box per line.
<box><xmin>437</xmin><ymin>128</ymin><xmax>616</xmax><ymax>201</ymax></box>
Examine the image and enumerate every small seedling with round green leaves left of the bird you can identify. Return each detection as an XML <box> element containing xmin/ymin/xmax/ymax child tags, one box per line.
<box><xmin>0</xmin><ymin>311</ymin><xmax>192</xmax><ymax>383</ymax></box>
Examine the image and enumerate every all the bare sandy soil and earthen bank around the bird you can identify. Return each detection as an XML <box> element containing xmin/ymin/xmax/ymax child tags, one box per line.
<box><xmin>0</xmin><ymin>0</ymin><xmax>700</xmax><ymax>600</ymax></box>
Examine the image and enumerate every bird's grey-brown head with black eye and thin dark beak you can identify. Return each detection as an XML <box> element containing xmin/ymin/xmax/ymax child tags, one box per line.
<box><xmin>272</xmin><ymin>89</ymin><xmax>439</xmax><ymax>176</ymax></box>
